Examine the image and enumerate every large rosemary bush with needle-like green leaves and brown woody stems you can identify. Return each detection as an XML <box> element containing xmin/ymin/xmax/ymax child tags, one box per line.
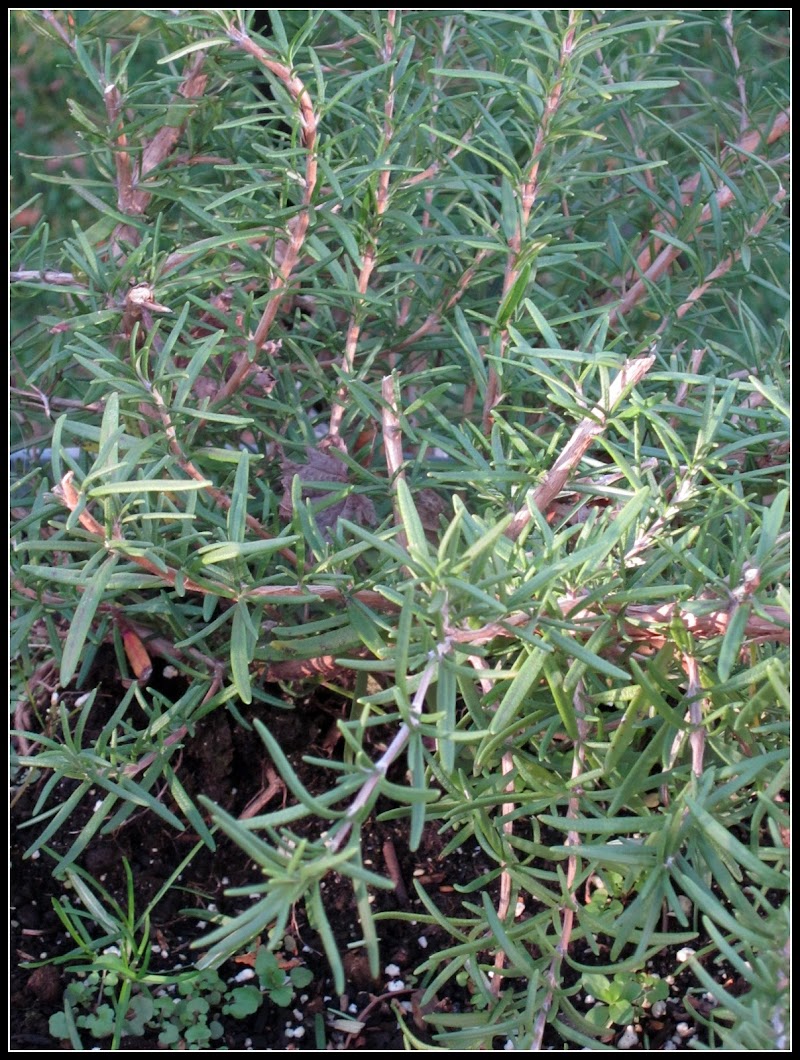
<box><xmin>11</xmin><ymin>11</ymin><xmax>789</xmax><ymax>1048</ymax></box>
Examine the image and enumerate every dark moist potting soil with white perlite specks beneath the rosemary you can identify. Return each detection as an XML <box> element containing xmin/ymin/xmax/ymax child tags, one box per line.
<box><xmin>11</xmin><ymin>652</ymin><xmax>733</xmax><ymax>1050</ymax></box>
